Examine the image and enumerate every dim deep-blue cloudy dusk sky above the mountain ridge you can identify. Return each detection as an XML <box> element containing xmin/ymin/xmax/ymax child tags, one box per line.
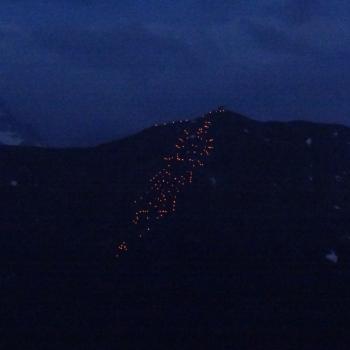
<box><xmin>0</xmin><ymin>0</ymin><xmax>350</xmax><ymax>145</ymax></box>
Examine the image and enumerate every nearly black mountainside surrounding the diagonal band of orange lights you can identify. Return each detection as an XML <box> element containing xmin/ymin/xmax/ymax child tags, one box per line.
<box><xmin>0</xmin><ymin>111</ymin><xmax>350</xmax><ymax>350</ymax></box>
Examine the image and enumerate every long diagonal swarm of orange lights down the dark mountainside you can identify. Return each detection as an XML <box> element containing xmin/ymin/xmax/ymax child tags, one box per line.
<box><xmin>116</xmin><ymin>107</ymin><xmax>224</xmax><ymax>258</ymax></box>
